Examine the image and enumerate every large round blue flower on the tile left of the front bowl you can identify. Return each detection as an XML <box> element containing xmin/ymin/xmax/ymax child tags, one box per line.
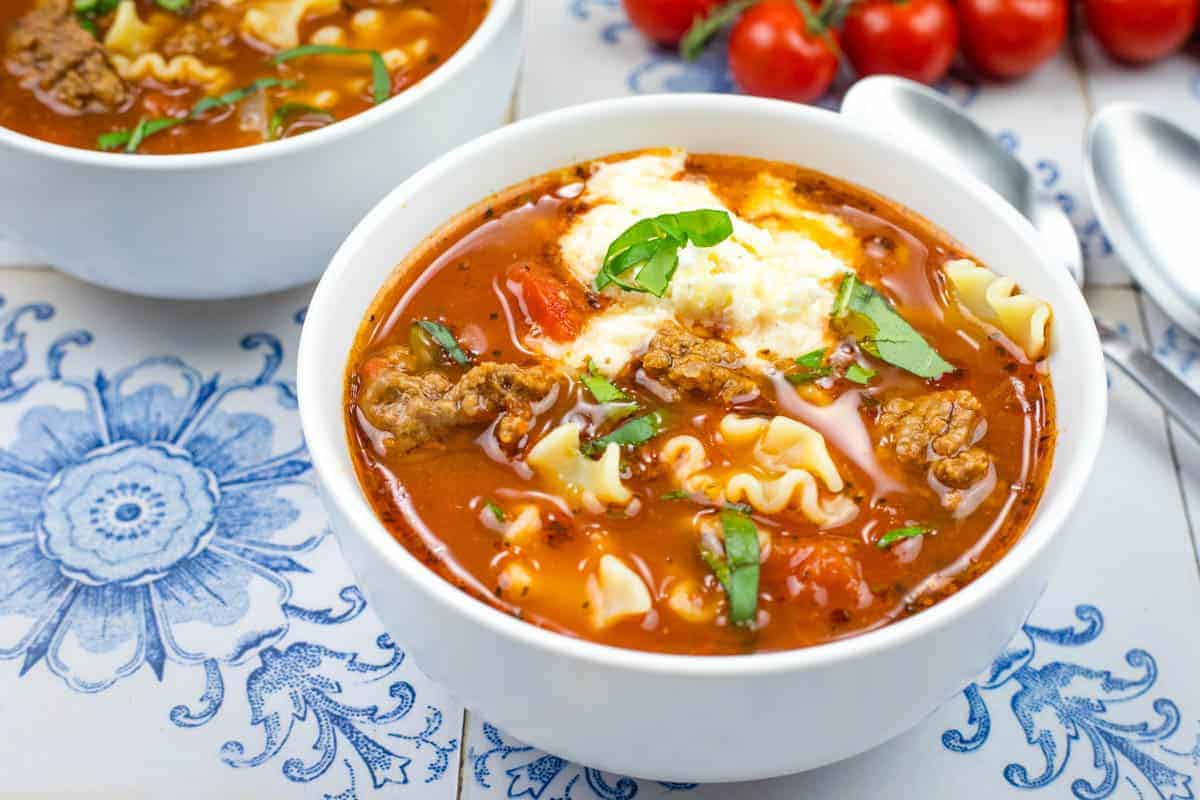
<box><xmin>0</xmin><ymin>309</ymin><xmax>314</xmax><ymax>692</ymax></box>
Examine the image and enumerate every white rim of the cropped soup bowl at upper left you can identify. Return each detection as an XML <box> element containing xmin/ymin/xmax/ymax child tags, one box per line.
<box><xmin>0</xmin><ymin>0</ymin><xmax>522</xmax><ymax>172</ymax></box>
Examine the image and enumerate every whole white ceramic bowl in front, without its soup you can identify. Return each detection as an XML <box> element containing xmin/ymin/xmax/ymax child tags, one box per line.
<box><xmin>299</xmin><ymin>95</ymin><xmax>1106</xmax><ymax>781</ymax></box>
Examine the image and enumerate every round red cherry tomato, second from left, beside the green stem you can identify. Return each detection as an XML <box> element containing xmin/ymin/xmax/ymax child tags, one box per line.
<box><xmin>730</xmin><ymin>0</ymin><xmax>838</xmax><ymax>103</ymax></box>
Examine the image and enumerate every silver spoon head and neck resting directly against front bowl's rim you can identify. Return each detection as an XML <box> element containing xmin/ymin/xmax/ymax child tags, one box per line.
<box><xmin>841</xmin><ymin>76</ymin><xmax>1084</xmax><ymax>285</ymax></box>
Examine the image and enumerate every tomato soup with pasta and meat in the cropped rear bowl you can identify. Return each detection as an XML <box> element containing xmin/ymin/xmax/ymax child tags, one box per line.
<box><xmin>0</xmin><ymin>0</ymin><xmax>487</xmax><ymax>154</ymax></box>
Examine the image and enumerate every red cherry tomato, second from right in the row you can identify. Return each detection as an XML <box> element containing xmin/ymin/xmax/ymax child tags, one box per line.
<box><xmin>958</xmin><ymin>0</ymin><xmax>1068</xmax><ymax>78</ymax></box>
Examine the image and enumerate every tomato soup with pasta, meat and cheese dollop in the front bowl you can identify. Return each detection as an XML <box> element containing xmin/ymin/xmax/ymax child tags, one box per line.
<box><xmin>346</xmin><ymin>150</ymin><xmax>1055</xmax><ymax>655</ymax></box>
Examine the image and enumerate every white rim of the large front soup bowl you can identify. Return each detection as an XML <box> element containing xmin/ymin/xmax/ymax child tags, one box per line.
<box><xmin>296</xmin><ymin>94</ymin><xmax>1108</xmax><ymax>679</ymax></box>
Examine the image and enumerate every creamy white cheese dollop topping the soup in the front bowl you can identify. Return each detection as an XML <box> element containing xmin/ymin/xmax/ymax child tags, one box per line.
<box><xmin>544</xmin><ymin>151</ymin><xmax>857</xmax><ymax>375</ymax></box>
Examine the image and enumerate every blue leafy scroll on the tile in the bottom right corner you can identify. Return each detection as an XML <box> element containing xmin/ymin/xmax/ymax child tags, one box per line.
<box><xmin>942</xmin><ymin>606</ymin><xmax>1200</xmax><ymax>800</ymax></box>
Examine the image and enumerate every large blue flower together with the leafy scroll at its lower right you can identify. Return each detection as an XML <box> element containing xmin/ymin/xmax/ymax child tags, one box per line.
<box><xmin>0</xmin><ymin>297</ymin><xmax>458</xmax><ymax>798</ymax></box>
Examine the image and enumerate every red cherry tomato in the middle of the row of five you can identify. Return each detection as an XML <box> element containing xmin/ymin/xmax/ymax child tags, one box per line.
<box><xmin>841</xmin><ymin>0</ymin><xmax>959</xmax><ymax>83</ymax></box>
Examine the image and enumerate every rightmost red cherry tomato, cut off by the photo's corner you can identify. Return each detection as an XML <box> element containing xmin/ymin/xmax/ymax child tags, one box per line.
<box><xmin>1084</xmin><ymin>0</ymin><xmax>1198</xmax><ymax>64</ymax></box>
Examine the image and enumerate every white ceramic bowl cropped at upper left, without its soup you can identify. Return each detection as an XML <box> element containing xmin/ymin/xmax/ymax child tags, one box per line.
<box><xmin>0</xmin><ymin>0</ymin><xmax>522</xmax><ymax>299</ymax></box>
